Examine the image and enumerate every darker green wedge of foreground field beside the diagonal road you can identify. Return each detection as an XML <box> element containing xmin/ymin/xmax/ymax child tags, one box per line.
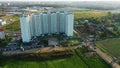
<box><xmin>75</xmin><ymin>50</ymin><xmax>111</xmax><ymax>68</ymax></box>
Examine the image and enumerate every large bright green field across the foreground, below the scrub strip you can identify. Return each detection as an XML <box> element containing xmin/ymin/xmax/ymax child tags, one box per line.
<box><xmin>0</xmin><ymin>49</ymin><xmax>111</xmax><ymax>68</ymax></box>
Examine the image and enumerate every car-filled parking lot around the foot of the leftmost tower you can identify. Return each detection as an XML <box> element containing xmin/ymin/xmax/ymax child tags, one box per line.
<box><xmin>0</xmin><ymin>38</ymin><xmax>43</xmax><ymax>52</ymax></box>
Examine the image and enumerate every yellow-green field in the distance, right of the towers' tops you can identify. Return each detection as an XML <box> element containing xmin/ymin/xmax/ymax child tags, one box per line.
<box><xmin>72</xmin><ymin>11</ymin><xmax>107</xmax><ymax>20</ymax></box>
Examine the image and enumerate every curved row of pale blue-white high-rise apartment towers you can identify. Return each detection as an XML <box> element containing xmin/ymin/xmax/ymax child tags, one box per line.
<box><xmin>20</xmin><ymin>11</ymin><xmax>74</xmax><ymax>42</ymax></box>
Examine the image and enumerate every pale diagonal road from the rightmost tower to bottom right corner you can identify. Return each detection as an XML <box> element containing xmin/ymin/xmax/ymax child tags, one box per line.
<box><xmin>75</xmin><ymin>29</ymin><xmax>120</xmax><ymax>68</ymax></box>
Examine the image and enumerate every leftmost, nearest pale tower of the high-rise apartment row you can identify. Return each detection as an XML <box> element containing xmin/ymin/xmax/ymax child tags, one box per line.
<box><xmin>20</xmin><ymin>16</ymin><xmax>32</xmax><ymax>42</ymax></box>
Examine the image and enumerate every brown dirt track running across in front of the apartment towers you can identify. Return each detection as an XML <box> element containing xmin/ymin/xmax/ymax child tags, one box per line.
<box><xmin>3</xmin><ymin>46</ymin><xmax>79</xmax><ymax>56</ymax></box>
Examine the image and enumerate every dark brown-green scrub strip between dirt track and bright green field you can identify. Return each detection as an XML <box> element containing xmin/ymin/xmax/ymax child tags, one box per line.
<box><xmin>12</xmin><ymin>50</ymin><xmax>73</xmax><ymax>60</ymax></box>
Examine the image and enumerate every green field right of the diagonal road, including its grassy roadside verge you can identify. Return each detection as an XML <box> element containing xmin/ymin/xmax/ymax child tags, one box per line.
<box><xmin>97</xmin><ymin>38</ymin><xmax>120</xmax><ymax>64</ymax></box>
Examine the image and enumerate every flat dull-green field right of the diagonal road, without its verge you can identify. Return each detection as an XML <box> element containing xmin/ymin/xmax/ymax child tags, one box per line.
<box><xmin>99</xmin><ymin>38</ymin><xmax>120</xmax><ymax>56</ymax></box>
